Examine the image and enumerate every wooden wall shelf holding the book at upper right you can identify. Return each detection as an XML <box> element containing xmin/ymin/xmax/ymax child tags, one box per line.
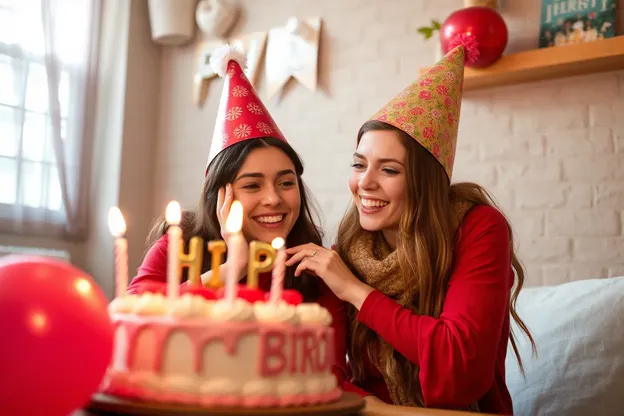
<box><xmin>420</xmin><ymin>36</ymin><xmax>624</xmax><ymax>91</ymax></box>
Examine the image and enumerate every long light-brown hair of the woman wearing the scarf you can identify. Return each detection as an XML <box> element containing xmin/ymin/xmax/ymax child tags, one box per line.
<box><xmin>336</xmin><ymin>121</ymin><xmax>536</xmax><ymax>405</ymax></box>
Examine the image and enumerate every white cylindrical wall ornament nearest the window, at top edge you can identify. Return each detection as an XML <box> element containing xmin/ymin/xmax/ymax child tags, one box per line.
<box><xmin>147</xmin><ymin>0</ymin><xmax>196</xmax><ymax>46</ymax></box>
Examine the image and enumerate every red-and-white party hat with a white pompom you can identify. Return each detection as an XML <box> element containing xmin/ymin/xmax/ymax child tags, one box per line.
<box><xmin>206</xmin><ymin>45</ymin><xmax>286</xmax><ymax>174</ymax></box>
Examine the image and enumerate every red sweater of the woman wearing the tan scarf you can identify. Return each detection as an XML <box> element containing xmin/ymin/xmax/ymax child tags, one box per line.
<box><xmin>345</xmin><ymin>206</ymin><xmax>514</xmax><ymax>414</ymax></box>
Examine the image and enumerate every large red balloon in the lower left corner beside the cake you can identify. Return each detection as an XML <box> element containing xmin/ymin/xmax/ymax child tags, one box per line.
<box><xmin>0</xmin><ymin>256</ymin><xmax>114</xmax><ymax>416</ymax></box>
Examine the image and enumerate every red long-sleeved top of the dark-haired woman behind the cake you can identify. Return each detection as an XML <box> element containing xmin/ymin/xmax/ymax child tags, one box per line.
<box><xmin>127</xmin><ymin>234</ymin><xmax>360</xmax><ymax>395</ymax></box>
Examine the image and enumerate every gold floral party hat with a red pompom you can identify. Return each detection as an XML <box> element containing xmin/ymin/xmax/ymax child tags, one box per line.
<box><xmin>371</xmin><ymin>35</ymin><xmax>479</xmax><ymax>180</ymax></box>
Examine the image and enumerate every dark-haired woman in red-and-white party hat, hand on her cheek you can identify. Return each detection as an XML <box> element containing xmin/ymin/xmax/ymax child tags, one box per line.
<box><xmin>128</xmin><ymin>47</ymin><xmax>356</xmax><ymax>394</ymax></box>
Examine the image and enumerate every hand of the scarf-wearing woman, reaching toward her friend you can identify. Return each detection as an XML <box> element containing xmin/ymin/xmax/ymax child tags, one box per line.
<box><xmin>286</xmin><ymin>243</ymin><xmax>373</xmax><ymax>310</ymax></box>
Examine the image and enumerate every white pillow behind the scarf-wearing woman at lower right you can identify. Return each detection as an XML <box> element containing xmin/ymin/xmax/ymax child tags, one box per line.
<box><xmin>506</xmin><ymin>276</ymin><xmax>624</xmax><ymax>416</ymax></box>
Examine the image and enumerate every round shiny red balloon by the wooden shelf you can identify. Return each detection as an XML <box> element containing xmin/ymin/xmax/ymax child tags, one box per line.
<box><xmin>440</xmin><ymin>7</ymin><xmax>509</xmax><ymax>68</ymax></box>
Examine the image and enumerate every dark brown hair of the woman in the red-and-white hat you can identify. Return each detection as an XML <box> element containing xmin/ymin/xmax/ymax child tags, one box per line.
<box><xmin>147</xmin><ymin>138</ymin><xmax>323</xmax><ymax>301</ymax></box>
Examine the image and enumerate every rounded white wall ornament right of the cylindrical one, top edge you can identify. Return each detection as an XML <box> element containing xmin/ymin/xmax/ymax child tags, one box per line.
<box><xmin>195</xmin><ymin>0</ymin><xmax>239</xmax><ymax>38</ymax></box>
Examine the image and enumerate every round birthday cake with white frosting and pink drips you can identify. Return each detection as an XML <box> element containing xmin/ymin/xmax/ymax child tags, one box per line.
<box><xmin>101</xmin><ymin>292</ymin><xmax>341</xmax><ymax>407</ymax></box>
